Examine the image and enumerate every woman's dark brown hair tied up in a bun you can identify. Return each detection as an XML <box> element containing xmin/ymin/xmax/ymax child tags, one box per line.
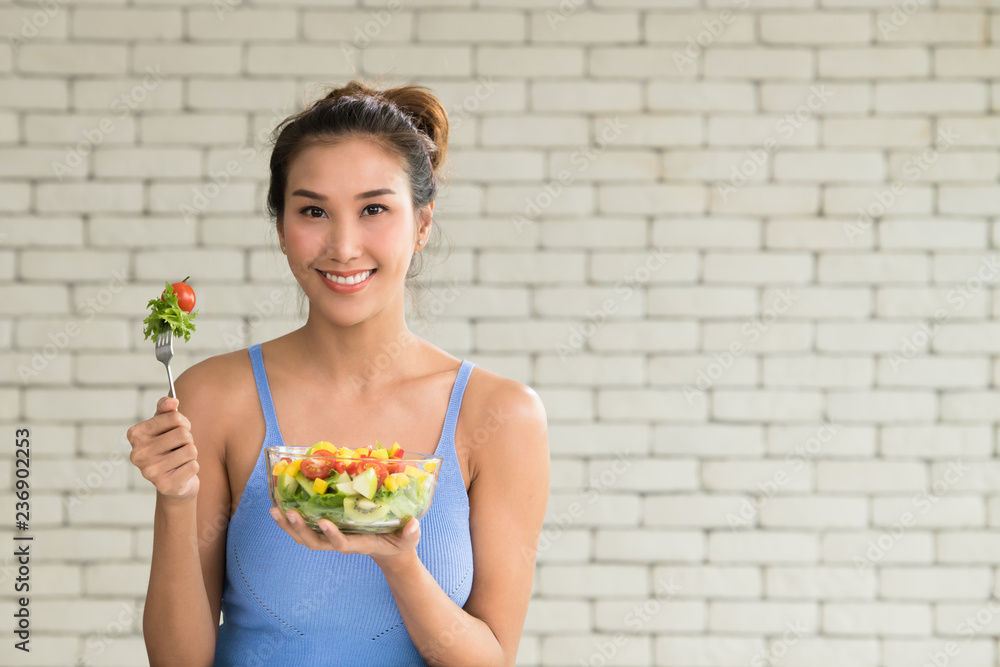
<box><xmin>267</xmin><ymin>79</ymin><xmax>448</xmax><ymax>324</ymax></box>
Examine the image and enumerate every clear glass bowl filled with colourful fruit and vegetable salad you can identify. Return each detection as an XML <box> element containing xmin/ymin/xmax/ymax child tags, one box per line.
<box><xmin>267</xmin><ymin>441</ymin><xmax>442</xmax><ymax>533</ymax></box>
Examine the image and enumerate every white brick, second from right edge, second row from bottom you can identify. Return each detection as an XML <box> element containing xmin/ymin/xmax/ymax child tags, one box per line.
<box><xmin>823</xmin><ymin>602</ymin><xmax>932</xmax><ymax>636</ymax></box>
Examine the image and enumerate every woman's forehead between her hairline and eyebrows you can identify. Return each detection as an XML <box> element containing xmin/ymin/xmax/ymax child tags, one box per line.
<box><xmin>288</xmin><ymin>139</ymin><xmax>408</xmax><ymax>197</ymax></box>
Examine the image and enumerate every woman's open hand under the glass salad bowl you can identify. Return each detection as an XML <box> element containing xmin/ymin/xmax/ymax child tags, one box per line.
<box><xmin>270</xmin><ymin>507</ymin><xmax>420</xmax><ymax>564</ymax></box>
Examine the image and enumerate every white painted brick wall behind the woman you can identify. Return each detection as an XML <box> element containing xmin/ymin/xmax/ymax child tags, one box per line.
<box><xmin>0</xmin><ymin>0</ymin><xmax>1000</xmax><ymax>667</ymax></box>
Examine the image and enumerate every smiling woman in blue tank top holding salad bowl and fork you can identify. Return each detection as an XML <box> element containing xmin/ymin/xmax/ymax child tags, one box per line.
<box><xmin>128</xmin><ymin>82</ymin><xmax>549</xmax><ymax>667</ymax></box>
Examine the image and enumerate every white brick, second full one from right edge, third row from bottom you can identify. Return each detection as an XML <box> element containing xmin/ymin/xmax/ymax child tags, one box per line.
<box><xmin>764</xmin><ymin>566</ymin><xmax>876</xmax><ymax>600</ymax></box>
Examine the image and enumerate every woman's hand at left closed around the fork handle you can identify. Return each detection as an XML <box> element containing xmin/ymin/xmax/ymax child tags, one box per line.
<box><xmin>125</xmin><ymin>396</ymin><xmax>199</xmax><ymax>500</ymax></box>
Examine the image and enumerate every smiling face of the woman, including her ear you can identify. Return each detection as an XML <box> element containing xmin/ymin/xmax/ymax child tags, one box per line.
<box><xmin>277</xmin><ymin>139</ymin><xmax>434</xmax><ymax>326</ymax></box>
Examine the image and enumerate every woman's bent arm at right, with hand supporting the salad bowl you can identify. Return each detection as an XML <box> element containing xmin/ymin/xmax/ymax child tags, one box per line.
<box><xmin>271</xmin><ymin>380</ymin><xmax>549</xmax><ymax>667</ymax></box>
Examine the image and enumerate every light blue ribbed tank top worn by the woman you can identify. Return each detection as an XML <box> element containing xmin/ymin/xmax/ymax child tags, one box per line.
<box><xmin>214</xmin><ymin>343</ymin><xmax>475</xmax><ymax>667</ymax></box>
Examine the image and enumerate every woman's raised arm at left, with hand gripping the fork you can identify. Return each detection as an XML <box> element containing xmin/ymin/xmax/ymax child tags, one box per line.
<box><xmin>129</xmin><ymin>364</ymin><xmax>230</xmax><ymax>667</ymax></box>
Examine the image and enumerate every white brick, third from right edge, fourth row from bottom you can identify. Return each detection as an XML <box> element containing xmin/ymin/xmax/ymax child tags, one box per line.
<box><xmin>708</xmin><ymin>531</ymin><xmax>819</xmax><ymax>565</ymax></box>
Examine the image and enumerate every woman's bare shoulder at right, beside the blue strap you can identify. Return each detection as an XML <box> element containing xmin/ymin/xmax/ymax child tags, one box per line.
<box><xmin>462</xmin><ymin>366</ymin><xmax>549</xmax><ymax>474</ymax></box>
